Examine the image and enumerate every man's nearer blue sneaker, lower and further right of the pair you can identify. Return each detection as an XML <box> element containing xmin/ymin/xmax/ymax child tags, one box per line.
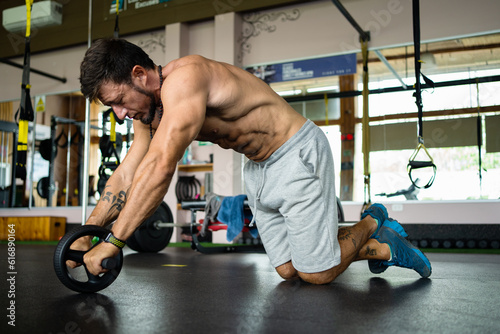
<box><xmin>378</xmin><ymin>226</ymin><xmax>432</xmax><ymax>278</ymax></box>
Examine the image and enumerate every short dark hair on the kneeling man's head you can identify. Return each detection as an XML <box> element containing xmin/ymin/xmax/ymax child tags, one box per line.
<box><xmin>80</xmin><ymin>38</ymin><xmax>155</xmax><ymax>101</ymax></box>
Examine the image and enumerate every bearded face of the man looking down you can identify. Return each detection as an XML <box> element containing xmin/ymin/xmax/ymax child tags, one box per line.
<box><xmin>99</xmin><ymin>82</ymin><xmax>157</xmax><ymax>124</ymax></box>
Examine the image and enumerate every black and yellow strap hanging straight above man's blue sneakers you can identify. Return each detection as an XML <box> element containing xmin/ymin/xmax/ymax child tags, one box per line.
<box><xmin>361</xmin><ymin>40</ymin><xmax>371</xmax><ymax>212</ymax></box>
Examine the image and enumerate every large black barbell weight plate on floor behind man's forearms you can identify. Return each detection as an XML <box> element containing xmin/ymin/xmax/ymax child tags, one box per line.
<box><xmin>127</xmin><ymin>202</ymin><xmax>174</xmax><ymax>253</ymax></box>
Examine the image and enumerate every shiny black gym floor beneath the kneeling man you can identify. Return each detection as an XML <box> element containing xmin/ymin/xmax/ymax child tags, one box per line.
<box><xmin>0</xmin><ymin>243</ymin><xmax>500</xmax><ymax>334</ymax></box>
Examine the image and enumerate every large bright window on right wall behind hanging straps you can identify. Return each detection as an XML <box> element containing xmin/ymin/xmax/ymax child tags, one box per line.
<box><xmin>354</xmin><ymin>70</ymin><xmax>500</xmax><ymax>201</ymax></box>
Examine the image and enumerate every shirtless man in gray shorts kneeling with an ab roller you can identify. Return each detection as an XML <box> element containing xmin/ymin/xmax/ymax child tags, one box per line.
<box><xmin>76</xmin><ymin>39</ymin><xmax>431</xmax><ymax>284</ymax></box>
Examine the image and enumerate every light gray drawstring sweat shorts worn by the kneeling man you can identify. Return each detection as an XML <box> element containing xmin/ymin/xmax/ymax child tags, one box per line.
<box><xmin>244</xmin><ymin>120</ymin><xmax>340</xmax><ymax>273</ymax></box>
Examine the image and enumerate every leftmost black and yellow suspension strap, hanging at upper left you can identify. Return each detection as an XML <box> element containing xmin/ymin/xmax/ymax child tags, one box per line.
<box><xmin>16</xmin><ymin>0</ymin><xmax>34</xmax><ymax>180</ymax></box>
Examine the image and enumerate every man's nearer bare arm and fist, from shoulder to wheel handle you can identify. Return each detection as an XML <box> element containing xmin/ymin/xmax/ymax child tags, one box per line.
<box><xmin>85</xmin><ymin>65</ymin><xmax>210</xmax><ymax>275</ymax></box>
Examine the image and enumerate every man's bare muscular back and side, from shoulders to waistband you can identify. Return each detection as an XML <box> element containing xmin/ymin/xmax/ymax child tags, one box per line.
<box><xmin>165</xmin><ymin>56</ymin><xmax>305</xmax><ymax>161</ymax></box>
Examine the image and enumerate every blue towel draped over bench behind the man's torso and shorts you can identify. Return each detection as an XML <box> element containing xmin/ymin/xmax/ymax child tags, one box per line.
<box><xmin>217</xmin><ymin>195</ymin><xmax>259</xmax><ymax>241</ymax></box>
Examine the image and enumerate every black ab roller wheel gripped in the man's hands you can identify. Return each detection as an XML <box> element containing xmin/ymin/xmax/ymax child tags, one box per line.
<box><xmin>54</xmin><ymin>225</ymin><xmax>123</xmax><ymax>293</ymax></box>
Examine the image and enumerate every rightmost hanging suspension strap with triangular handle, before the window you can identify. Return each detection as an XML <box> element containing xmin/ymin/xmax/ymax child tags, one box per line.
<box><xmin>407</xmin><ymin>0</ymin><xmax>437</xmax><ymax>188</ymax></box>
